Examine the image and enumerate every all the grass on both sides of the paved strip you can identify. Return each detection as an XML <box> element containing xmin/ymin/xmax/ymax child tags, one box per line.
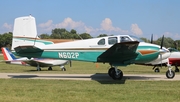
<box><xmin>0</xmin><ymin>56</ymin><xmax>180</xmax><ymax>102</ymax></box>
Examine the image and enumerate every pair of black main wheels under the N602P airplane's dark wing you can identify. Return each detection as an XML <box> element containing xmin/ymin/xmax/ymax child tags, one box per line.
<box><xmin>108</xmin><ymin>67</ymin><xmax>123</xmax><ymax>80</ymax></box>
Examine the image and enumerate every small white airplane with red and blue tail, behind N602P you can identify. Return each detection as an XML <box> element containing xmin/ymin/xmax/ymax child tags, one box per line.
<box><xmin>1</xmin><ymin>47</ymin><xmax>68</xmax><ymax>71</ymax></box>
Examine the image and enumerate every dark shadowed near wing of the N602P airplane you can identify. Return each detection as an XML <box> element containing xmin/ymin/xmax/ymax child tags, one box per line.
<box><xmin>97</xmin><ymin>41</ymin><xmax>139</xmax><ymax>65</ymax></box>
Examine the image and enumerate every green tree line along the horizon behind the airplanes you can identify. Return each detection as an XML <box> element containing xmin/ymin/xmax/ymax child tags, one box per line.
<box><xmin>0</xmin><ymin>28</ymin><xmax>180</xmax><ymax>50</ymax></box>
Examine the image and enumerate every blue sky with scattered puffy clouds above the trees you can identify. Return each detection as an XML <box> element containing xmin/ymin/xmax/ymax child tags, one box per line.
<box><xmin>0</xmin><ymin>0</ymin><xmax>180</xmax><ymax>40</ymax></box>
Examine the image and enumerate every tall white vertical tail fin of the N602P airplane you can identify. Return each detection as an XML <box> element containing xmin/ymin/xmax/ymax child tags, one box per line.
<box><xmin>11</xmin><ymin>15</ymin><xmax>53</xmax><ymax>51</ymax></box>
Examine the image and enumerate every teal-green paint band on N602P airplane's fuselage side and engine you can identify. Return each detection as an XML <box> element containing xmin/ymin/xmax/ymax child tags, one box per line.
<box><xmin>42</xmin><ymin>46</ymin><xmax>159</xmax><ymax>63</ymax></box>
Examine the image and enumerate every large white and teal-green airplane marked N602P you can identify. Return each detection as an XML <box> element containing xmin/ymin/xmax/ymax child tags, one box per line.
<box><xmin>12</xmin><ymin>16</ymin><xmax>175</xmax><ymax>79</ymax></box>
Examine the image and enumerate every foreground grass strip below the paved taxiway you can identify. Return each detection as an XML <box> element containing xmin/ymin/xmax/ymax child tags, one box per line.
<box><xmin>0</xmin><ymin>79</ymin><xmax>180</xmax><ymax>102</ymax></box>
